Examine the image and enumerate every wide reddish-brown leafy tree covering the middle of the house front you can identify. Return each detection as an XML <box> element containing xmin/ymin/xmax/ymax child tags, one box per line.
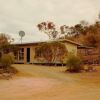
<box><xmin>35</xmin><ymin>42</ymin><xmax>67</xmax><ymax>63</ymax></box>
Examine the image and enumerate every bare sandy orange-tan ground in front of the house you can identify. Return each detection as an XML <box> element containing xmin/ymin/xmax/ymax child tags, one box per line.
<box><xmin>0</xmin><ymin>65</ymin><xmax>100</xmax><ymax>100</ymax></box>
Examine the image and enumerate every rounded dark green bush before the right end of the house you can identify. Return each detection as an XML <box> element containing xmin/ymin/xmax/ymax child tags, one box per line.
<box><xmin>67</xmin><ymin>54</ymin><xmax>82</xmax><ymax>72</ymax></box>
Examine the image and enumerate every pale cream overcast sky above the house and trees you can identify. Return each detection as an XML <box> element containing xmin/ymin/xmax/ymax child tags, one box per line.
<box><xmin>0</xmin><ymin>0</ymin><xmax>100</xmax><ymax>42</ymax></box>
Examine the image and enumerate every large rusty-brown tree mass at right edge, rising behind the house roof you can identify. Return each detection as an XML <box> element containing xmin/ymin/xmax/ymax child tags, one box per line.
<box><xmin>75</xmin><ymin>22</ymin><xmax>100</xmax><ymax>47</ymax></box>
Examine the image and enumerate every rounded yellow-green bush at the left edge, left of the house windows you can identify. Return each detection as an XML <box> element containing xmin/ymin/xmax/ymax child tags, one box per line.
<box><xmin>0</xmin><ymin>53</ymin><xmax>14</xmax><ymax>69</ymax></box>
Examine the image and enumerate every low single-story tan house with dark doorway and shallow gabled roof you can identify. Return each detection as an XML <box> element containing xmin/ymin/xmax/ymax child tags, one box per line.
<box><xmin>14</xmin><ymin>39</ymin><xmax>81</xmax><ymax>63</ymax></box>
